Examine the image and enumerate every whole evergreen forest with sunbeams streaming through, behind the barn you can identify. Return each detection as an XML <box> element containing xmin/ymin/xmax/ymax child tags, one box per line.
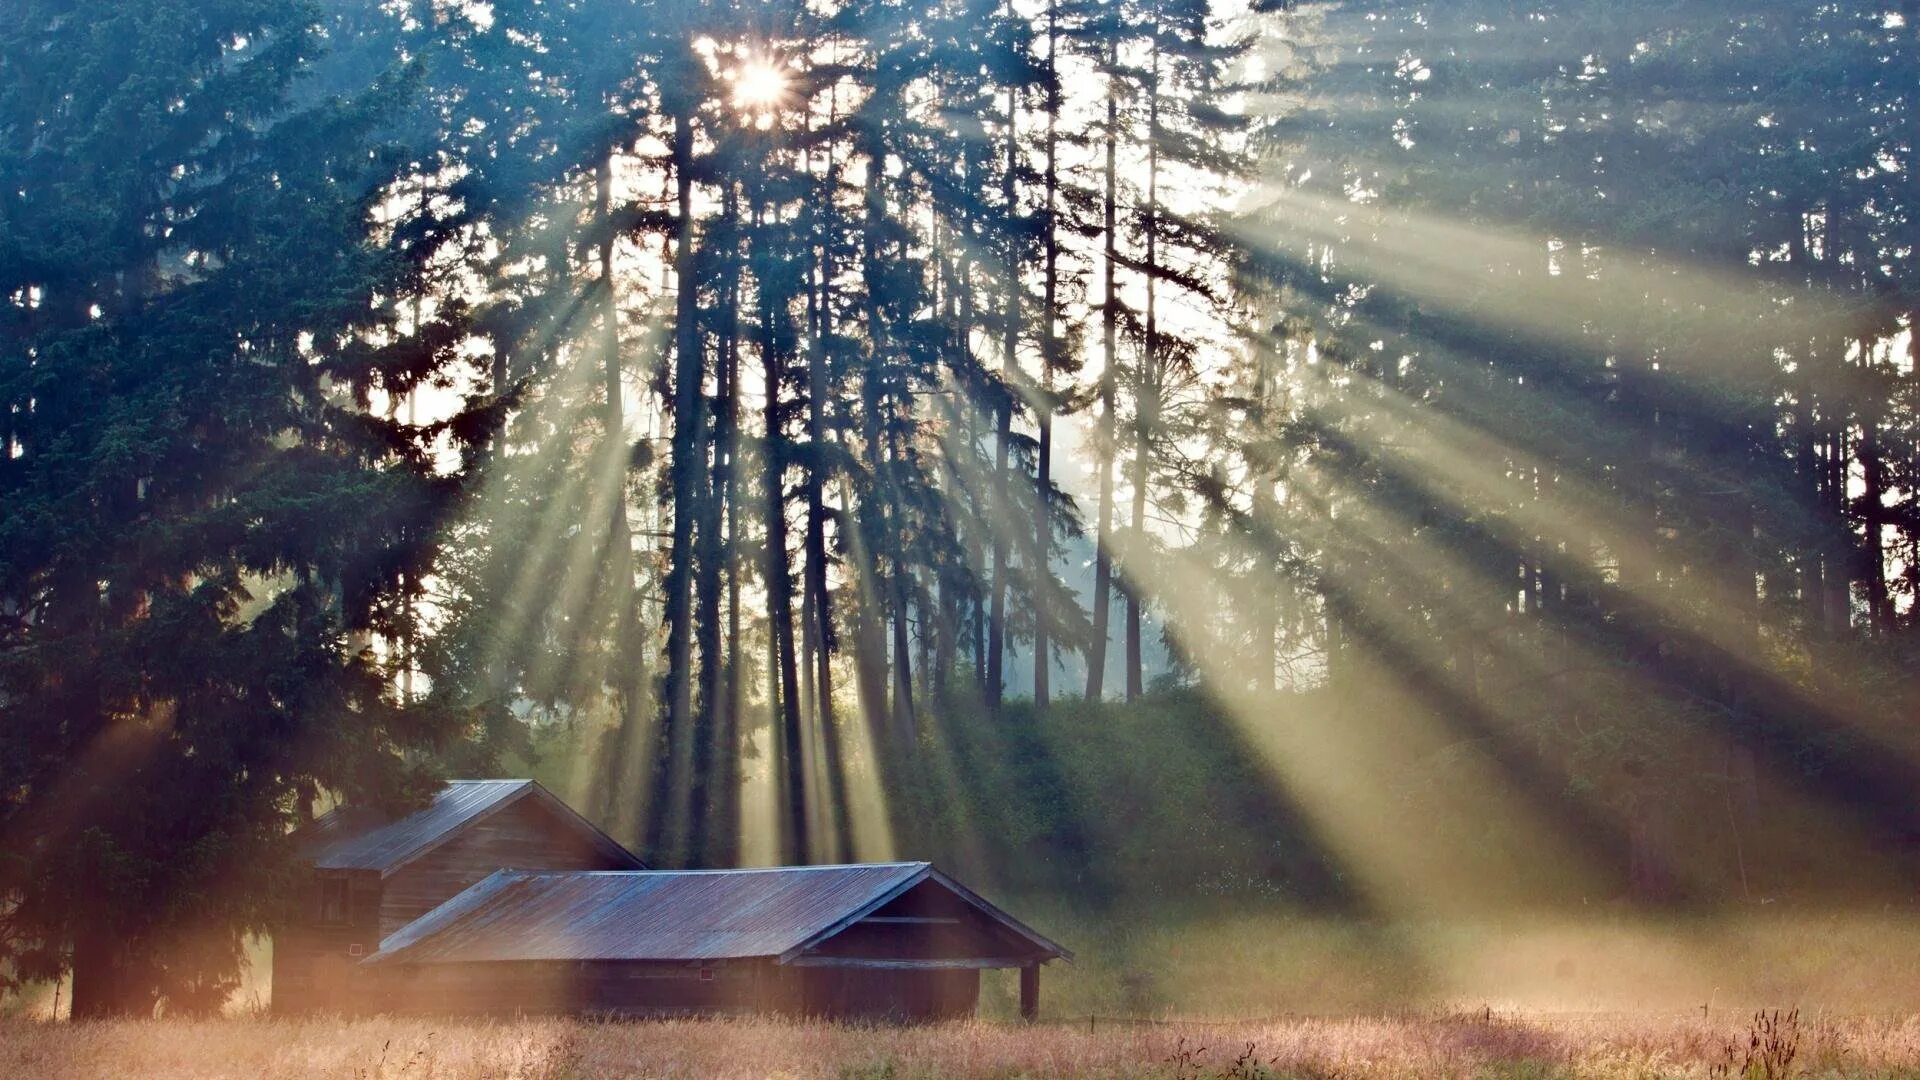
<box><xmin>0</xmin><ymin>0</ymin><xmax>1920</xmax><ymax>1017</ymax></box>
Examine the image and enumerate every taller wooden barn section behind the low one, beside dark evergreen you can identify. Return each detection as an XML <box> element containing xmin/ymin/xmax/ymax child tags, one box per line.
<box><xmin>273</xmin><ymin>780</ymin><xmax>645</xmax><ymax>1013</ymax></box>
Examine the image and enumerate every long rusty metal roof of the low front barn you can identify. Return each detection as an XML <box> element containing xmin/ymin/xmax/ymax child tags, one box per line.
<box><xmin>367</xmin><ymin>863</ymin><xmax>1068</xmax><ymax>963</ymax></box>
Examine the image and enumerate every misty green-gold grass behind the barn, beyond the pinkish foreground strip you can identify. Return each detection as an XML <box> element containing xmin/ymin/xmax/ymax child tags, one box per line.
<box><xmin>0</xmin><ymin>903</ymin><xmax>1920</xmax><ymax>1022</ymax></box>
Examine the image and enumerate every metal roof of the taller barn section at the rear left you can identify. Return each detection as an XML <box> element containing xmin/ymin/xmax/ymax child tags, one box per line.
<box><xmin>296</xmin><ymin>780</ymin><xmax>645</xmax><ymax>874</ymax></box>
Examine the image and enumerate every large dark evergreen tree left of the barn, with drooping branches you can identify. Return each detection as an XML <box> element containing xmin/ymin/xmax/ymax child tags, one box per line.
<box><xmin>0</xmin><ymin>0</ymin><xmax>486</xmax><ymax>1017</ymax></box>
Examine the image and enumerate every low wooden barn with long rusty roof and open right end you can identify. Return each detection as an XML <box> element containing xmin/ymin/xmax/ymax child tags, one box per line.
<box><xmin>365</xmin><ymin>863</ymin><xmax>1069</xmax><ymax>1020</ymax></box>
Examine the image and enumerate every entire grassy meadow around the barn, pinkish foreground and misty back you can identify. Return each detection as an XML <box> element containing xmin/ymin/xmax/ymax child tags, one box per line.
<box><xmin>15</xmin><ymin>909</ymin><xmax>1920</xmax><ymax>1080</ymax></box>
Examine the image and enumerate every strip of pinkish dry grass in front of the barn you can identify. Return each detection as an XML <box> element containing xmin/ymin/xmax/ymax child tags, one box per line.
<box><xmin>0</xmin><ymin>1013</ymin><xmax>1920</xmax><ymax>1080</ymax></box>
